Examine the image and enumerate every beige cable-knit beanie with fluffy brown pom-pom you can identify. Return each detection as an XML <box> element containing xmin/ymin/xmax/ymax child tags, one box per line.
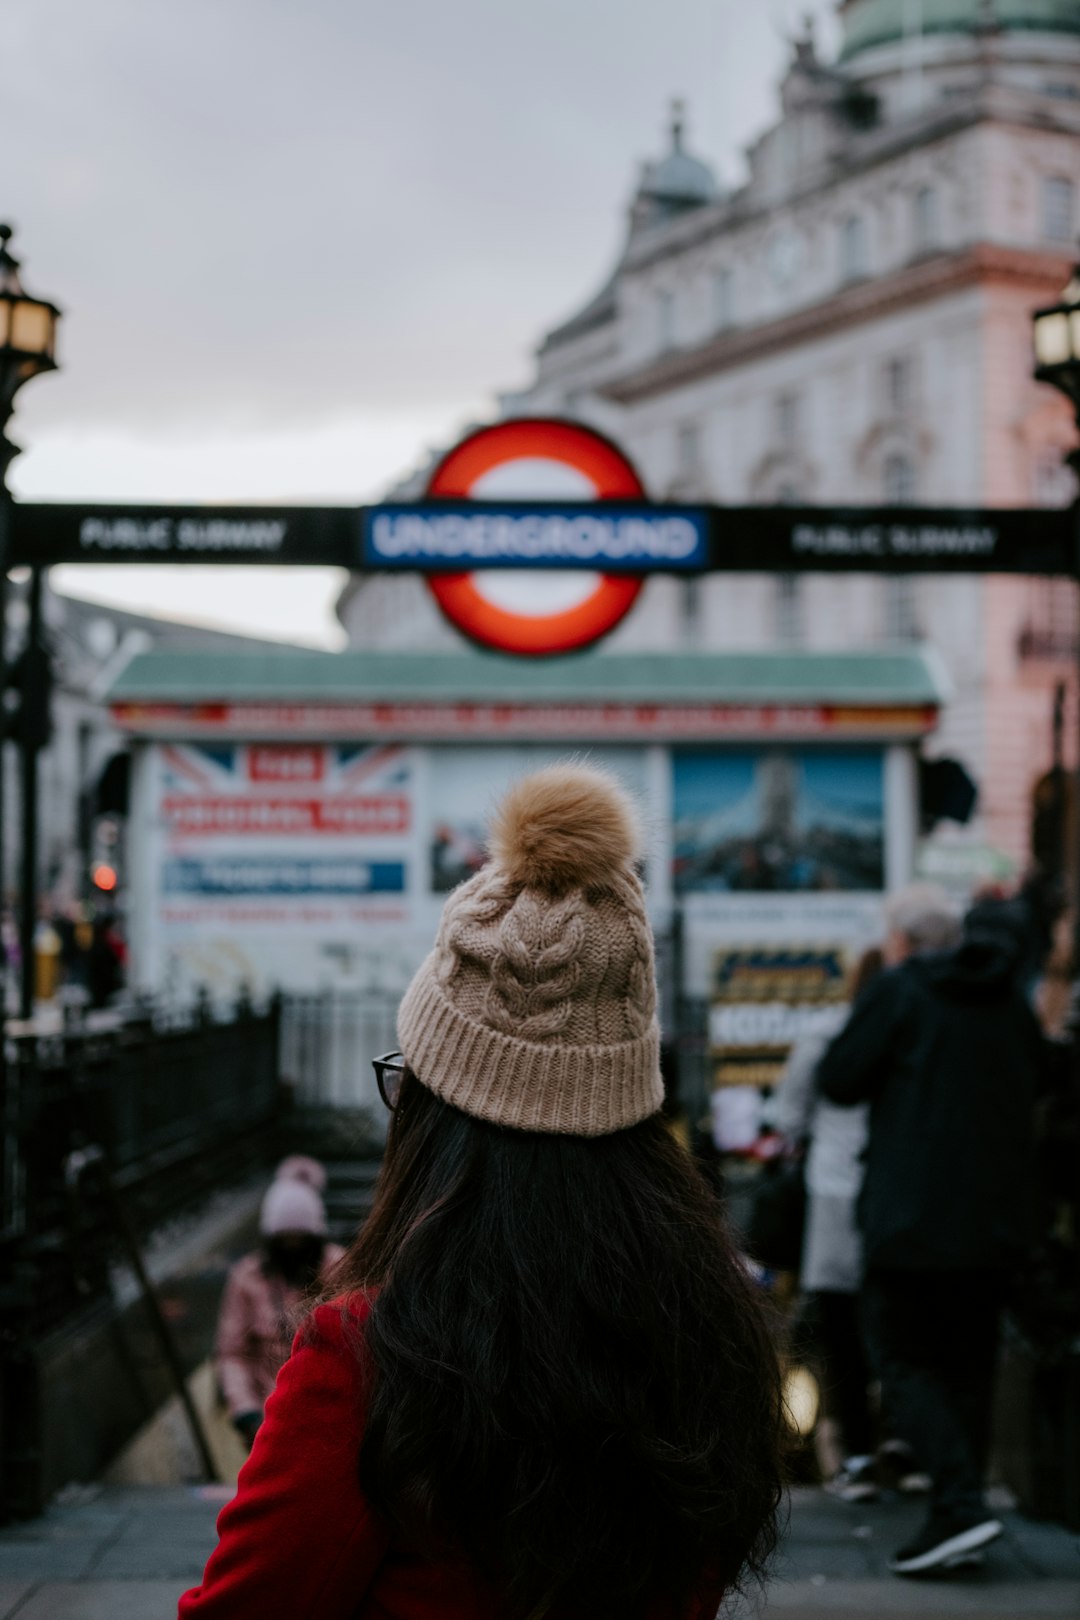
<box><xmin>398</xmin><ymin>765</ymin><xmax>664</xmax><ymax>1136</ymax></box>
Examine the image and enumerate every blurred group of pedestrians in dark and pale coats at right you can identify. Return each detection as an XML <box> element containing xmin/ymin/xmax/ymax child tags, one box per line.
<box><xmin>761</xmin><ymin>885</ymin><xmax>1080</xmax><ymax>1573</ymax></box>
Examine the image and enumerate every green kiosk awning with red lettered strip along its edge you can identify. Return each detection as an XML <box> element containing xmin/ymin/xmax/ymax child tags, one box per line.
<box><xmin>108</xmin><ymin>648</ymin><xmax>944</xmax><ymax>742</ymax></box>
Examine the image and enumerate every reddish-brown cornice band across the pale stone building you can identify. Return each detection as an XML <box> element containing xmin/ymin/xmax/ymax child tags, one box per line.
<box><xmin>596</xmin><ymin>243</ymin><xmax>1072</xmax><ymax>405</ymax></box>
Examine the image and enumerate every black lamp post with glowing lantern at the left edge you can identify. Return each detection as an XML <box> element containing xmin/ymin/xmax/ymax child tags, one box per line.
<box><xmin>0</xmin><ymin>225</ymin><xmax>60</xmax><ymax>1017</ymax></box>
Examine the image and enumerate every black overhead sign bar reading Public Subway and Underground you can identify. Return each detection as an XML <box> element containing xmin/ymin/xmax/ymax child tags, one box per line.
<box><xmin>10</xmin><ymin>501</ymin><xmax>1080</xmax><ymax>577</ymax></box>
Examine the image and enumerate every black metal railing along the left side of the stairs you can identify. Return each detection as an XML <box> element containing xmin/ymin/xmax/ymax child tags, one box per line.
<box><xmin>0</xmin><ymin>1003</ymin><xmax>282</xmax><ymax>1333</ymax></box>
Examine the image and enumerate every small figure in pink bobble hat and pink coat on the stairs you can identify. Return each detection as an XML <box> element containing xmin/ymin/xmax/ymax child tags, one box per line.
<box><xmin>214</xmin><ymin>1155</ymin><xmax>345</xmax><ymax>1447</ymax></box>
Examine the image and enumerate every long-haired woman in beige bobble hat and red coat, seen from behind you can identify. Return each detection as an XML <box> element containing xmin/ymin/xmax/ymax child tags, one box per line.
<box><xmin>180</xmin><ymin>765</ymin><xmax>785</xmax><ymax>1620</ymax></box>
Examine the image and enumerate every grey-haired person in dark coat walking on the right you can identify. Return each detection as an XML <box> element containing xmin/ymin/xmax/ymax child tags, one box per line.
<box><xmin>818</xmin><ymin>886</ymin><xmax>1044</xmax><ymax>1575</ymax></box>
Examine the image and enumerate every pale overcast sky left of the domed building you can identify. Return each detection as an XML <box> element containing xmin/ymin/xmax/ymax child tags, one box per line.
<box><xmin>0</xmin><ymin>0</ymin><xmax>834</xmax><ymax>645</ymax></box>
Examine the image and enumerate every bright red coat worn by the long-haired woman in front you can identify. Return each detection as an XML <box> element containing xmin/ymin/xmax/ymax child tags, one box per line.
<box><xmin>180</xmin><ymin>1299</ymin><xmax>722</xmax><ymax>1620</ymax></box>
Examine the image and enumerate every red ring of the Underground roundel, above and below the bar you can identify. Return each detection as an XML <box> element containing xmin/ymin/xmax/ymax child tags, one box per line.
<box><xmin>427</xmin><ymin>416</ymin><xmax>644</xmax><ymax>656</ymax></box>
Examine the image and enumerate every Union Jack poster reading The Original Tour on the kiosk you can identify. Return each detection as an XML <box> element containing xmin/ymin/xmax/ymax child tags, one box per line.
<box><xmin>144</xmin><ymin>742</ymin><xmax>416</xmax><ymax>993</ymax></box>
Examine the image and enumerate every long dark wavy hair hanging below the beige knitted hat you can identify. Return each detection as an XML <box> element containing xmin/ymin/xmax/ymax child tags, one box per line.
<box><xmin>320</xmin><ymin>1074</ymin><xmax>785</xmax><ymax>1620</ymax></box>
